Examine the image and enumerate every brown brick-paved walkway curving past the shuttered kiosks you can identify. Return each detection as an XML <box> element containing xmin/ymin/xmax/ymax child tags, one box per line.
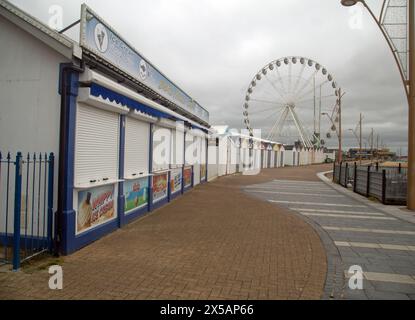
<box><xmin>0</xmin><ymin>165</ymin><xmax>331</xmax><ymax>299</ymax></box>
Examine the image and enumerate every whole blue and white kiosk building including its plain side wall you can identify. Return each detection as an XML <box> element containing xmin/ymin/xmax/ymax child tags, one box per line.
<box><xmin>0</xmin><ymin>0</ymin><xmax>210</xmax><ymax>254</ymax></box>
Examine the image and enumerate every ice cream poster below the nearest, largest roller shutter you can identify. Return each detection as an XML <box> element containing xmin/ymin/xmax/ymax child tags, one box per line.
<box><xmin>76</xmin><ymin>185</ymin><xmax>115</xmax><ymax>233</ymax></box>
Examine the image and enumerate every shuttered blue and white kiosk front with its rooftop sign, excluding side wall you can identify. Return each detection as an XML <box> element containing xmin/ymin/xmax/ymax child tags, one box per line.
<box><xmin>57</xmin><ymin>5</ymin><xmax>209</xmax><ymax>254</ymax></box>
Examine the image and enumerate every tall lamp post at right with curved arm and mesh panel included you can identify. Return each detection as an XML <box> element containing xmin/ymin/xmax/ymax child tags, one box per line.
<box><xmin>341</xmin><ymin>0</ymin><xmax>415</xmax><ymax>210</ymax></box>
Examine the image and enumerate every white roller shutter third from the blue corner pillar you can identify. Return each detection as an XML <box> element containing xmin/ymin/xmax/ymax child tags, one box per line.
<box><xmin>153</xmin><ymin>126</ymin><xmax>171</xmax><ymax>172</ymax></box>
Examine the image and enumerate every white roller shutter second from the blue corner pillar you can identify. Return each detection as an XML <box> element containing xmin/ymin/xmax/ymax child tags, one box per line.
<box><xmin>124</xmin><ymin>117</ymin><xmax>150</xmax><ymax>178</ymax></box>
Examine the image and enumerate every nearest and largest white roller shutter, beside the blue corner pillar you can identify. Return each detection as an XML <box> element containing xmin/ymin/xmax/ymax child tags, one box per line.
<box><xmin>75</xmin><ymin>104</ymin><xmax>119</xmax><ymax>186</ymax></box>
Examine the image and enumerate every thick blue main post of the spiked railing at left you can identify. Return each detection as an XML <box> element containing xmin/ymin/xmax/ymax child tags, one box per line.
<box><xmin>12</xmin><ymin>152</ymin><xmax>22</xmax><ymax>271</ymax></box>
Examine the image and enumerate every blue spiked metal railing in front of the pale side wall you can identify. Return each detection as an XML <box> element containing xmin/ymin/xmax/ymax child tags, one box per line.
<box><xmin>0</xmin><ymin>152</ymin><xmax>55</xmax><ymax>270</ymax></box>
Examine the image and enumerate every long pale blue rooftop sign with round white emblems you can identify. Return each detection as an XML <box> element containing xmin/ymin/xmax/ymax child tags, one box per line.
<box><xmin>81</xmin><ymin>4</ymin><xmax>209</xmax><ymax>123</ymax></box>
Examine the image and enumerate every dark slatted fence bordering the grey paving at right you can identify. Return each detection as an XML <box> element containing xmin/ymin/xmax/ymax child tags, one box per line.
<box><xmin>333</xmin><ymin>163</ymin><xmax>407</xmax><ymax>205</ymax></box>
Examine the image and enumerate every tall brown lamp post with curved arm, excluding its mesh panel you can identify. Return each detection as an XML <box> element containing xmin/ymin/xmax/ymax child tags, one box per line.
<box><xmin>341</xmin><ymin>0</ymin><xmax>415</xmax><ymax>210</ymax></box>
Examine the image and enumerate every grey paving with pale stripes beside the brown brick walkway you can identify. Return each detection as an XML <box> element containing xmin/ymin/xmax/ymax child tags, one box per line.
<box><xmin>245</xmin><ymin>179</ymin><xmax>415</xmax><ymax>299</ymax></box>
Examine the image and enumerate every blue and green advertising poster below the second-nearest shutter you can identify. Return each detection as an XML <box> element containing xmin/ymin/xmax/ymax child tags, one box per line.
<box><xmin>124</xmin><ymin>178</ymin><xmax>148</xmax><ymax>213</ymax></box>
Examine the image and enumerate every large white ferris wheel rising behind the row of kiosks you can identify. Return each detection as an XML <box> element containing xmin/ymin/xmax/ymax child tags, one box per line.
<box><xmin>243</xmin><ymin>56</ymin><xmax>340</xmax><ymax>148</ymax></box>
